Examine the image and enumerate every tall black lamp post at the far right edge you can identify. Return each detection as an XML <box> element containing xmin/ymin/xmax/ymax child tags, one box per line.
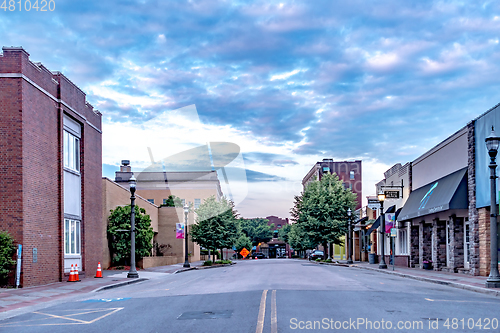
<box><xmin>485</xmin><ymin>126</ymin><xmax>500</xmax><ymax>288</ymax></box>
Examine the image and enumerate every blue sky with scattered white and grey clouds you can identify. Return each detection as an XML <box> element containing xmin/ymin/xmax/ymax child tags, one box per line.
<box><xmin>0</xmin><ymin>0</ymin><xmax>500</xmax><ymax>217</ymax></box>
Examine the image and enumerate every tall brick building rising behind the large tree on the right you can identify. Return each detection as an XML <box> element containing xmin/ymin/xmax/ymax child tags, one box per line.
<box><xmin>302</xmin><ymin>158</ymin><xmax>363</xmax><ymax>209</ymax></box>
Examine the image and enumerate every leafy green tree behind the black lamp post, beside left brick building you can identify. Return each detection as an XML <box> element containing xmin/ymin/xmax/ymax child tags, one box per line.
<box><xmin>108</xmin><ymin>205</ymin><xmax>154</xmax><ymax>264</ymax></box>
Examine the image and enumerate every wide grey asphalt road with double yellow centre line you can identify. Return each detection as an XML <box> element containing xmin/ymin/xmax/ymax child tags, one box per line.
<box><xmin>0</xmin><ymin>259</ymin><xmax>500</xmax><ymax>333</ymax></box>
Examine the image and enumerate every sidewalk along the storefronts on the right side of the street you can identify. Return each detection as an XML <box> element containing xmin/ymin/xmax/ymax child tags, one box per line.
<box><xmin>339</xmin><ymin>261</ymin><xmax>500</xmax><ymax>297</ymax></box>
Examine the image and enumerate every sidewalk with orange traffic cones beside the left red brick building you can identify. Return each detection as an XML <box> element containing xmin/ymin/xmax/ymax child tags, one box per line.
<box><xmin>0</xmin><ymin>261</ymin><xmax>203</xmax><ymax>320</ymax></box>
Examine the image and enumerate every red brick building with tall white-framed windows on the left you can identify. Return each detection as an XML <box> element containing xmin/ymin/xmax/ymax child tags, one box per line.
<box><xmin>0</xmin><ymin>47</ymin><xmax>102</xmax><ymax>287</ymax></box>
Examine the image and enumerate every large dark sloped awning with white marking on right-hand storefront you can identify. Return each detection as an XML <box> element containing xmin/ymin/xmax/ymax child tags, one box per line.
<box><xmin>398</xmin><ymin>168</ymin><xmax>469</xmax><ymax>221</ymax></box>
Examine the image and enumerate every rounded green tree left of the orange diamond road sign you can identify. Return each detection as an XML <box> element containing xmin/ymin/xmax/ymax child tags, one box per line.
<box><xmin>188</xmin><ymin>196</ymin><xmax>239</xmax><ymax>259</ymax></box>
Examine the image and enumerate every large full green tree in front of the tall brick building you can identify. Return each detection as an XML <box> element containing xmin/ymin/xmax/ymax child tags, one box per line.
<box><xmin>289</xmin><ymin>173</ymin><xmax>356</xmax><ymax>248</ymax></box>
